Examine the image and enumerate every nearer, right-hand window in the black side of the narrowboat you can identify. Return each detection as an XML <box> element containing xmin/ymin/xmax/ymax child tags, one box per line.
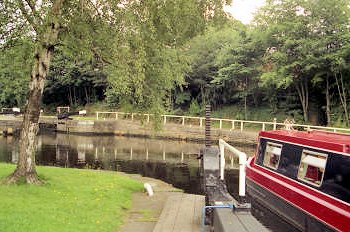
<box><xmin>298</xmin><ymin>150</ymin><xmax>327</xmax><ymax>187</ymax></box>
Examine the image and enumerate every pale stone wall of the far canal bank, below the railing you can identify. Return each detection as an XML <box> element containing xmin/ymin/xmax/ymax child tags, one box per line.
<box><xmin>0</xmin><ymin>117</ymin><xmax>257</xmax><ymax>145</ymax></box>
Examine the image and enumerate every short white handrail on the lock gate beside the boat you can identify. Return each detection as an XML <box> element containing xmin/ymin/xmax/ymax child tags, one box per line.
<box><xmin>219</xmin><ymin>139</ymin><xmax>247</xmax><ymax>197</ymax></box>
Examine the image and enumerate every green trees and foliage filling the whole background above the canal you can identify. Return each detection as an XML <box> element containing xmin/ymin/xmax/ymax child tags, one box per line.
<box><xmin>0</xmin><ymin>0</ymin><xmax>350</xmax><ymax>126</ymax></box>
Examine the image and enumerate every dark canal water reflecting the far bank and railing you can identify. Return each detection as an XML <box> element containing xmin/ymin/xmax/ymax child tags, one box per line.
<box><xmin>0</xmin><ymin>133</ymin><xmax>295</xmax><ymax>231</ymax></box>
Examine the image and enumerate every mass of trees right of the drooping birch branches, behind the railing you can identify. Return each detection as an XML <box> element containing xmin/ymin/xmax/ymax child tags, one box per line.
<box><xmin>182</xmin><ymin>0</ymin><xmax>350</xmax><ymax>126</ymax></box>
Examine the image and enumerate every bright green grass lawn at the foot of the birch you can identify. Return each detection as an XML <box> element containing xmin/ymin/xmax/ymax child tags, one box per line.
<box><xmin>0</xmin><ymin>163</ymin><xmax>143</xmax><ymax>232</ymax></box>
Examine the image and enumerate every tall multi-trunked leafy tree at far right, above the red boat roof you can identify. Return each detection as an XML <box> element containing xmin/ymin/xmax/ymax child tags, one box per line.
<box><xmin>255</xmin><ymin>0</ymin><xmax>349</xmax><ymax>124</ymax></box>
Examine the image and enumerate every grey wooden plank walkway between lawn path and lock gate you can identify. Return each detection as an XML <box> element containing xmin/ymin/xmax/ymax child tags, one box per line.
<box><xmin>153</xmin><ymin>193</ymin><xmax>205</xmax><ymax>232</ymax></box>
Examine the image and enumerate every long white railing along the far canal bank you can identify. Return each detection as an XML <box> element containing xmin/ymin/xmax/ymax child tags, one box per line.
<box><xmin>96</xmin><ymin>112</ymin><xmax>350</xmax><ymax>132</ymax></box>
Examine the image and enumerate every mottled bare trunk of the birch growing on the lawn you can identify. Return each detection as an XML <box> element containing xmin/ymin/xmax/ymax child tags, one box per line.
<box><xmin>7</xmin><ymin>0</ymin><xmax>63</xmax><ymax>184</ymax></box>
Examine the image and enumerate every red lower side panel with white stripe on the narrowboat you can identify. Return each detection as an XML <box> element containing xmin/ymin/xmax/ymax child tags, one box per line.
<box><xmin>246</xmin><ymin>162</ymin><xmax>350</xmax><ymax>231</ymax></box>
